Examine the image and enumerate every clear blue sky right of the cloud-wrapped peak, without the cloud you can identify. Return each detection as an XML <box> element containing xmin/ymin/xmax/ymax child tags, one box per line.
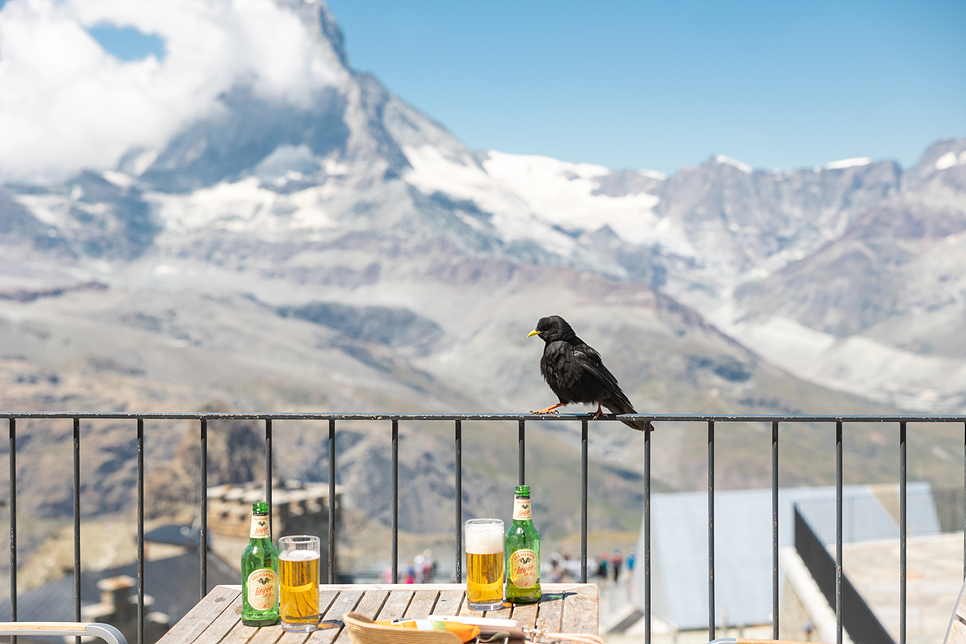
<box><xmin>329</xmin><ymin>0</ymin><xmax>966</xmax><ymax>172</ymax></box>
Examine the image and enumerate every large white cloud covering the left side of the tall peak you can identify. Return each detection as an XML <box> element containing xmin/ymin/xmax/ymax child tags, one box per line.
<box><xmin>0</xmin><ymin>0</ymin><xmax>346</xmax><ymax>180</ymax></box>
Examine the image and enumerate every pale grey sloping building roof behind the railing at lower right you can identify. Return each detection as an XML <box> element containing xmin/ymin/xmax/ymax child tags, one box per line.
<box><xmin>632</xmin><ymin>483</ymin><xmax>940</xmax><ymax>630</ymax></box>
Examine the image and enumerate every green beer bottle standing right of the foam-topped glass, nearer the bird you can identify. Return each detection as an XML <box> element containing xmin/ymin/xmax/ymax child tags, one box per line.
<box><xmin>505</xmin><ymin>485</ymin><xmax>541</xmax><ymax>604</ymax></box>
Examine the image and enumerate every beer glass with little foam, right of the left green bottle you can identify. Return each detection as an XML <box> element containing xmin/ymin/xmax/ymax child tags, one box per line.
<box><xmin>278</xmin><ymin>535</ymin><xmax>321</xmax><ymax>633</ymax></box>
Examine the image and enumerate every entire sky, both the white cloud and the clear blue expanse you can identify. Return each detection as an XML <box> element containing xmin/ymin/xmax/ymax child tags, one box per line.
<box><xmin>0</xmin><ymin>0</ymin><xmax>966</xmax><ymax>179</ymax></box>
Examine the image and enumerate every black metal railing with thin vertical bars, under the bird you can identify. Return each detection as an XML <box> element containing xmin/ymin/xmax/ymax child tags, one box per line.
<box><xmin>0</xmin><ymin>412</ymin><xmax>966</xmax><ymax>644</ymax></box>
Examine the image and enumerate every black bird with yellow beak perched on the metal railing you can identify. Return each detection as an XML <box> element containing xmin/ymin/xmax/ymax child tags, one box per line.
<box><xmin>527</xmin><ymin>315</ymin><xmax>648</xmax><ymax>431</ymax></box>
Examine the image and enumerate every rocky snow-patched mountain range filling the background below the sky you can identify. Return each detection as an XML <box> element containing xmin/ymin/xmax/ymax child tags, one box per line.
<box><xmin>0</xmin><ymin>0</ymin><xmax>966</xmax><ymax>552</ymax></box>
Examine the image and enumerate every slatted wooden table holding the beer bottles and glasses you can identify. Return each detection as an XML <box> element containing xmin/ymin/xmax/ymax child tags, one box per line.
<box><xmin>158</xmin><ymin>584</ymin><xmax>597</xmax><ymax>644</ymax></box>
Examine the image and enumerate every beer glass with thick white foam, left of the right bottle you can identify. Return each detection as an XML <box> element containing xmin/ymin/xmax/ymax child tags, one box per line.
<box><xmin>464</xmin><ymin>519</ymin><xmax>504</xmax><ymax>610</ymax></box>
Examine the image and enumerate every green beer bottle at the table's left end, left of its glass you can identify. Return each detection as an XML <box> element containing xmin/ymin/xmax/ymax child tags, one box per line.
<box><xmin>241</xmin><ymin>501</ymin><xmax>278</xmax><ymax>626</ymax></box>
